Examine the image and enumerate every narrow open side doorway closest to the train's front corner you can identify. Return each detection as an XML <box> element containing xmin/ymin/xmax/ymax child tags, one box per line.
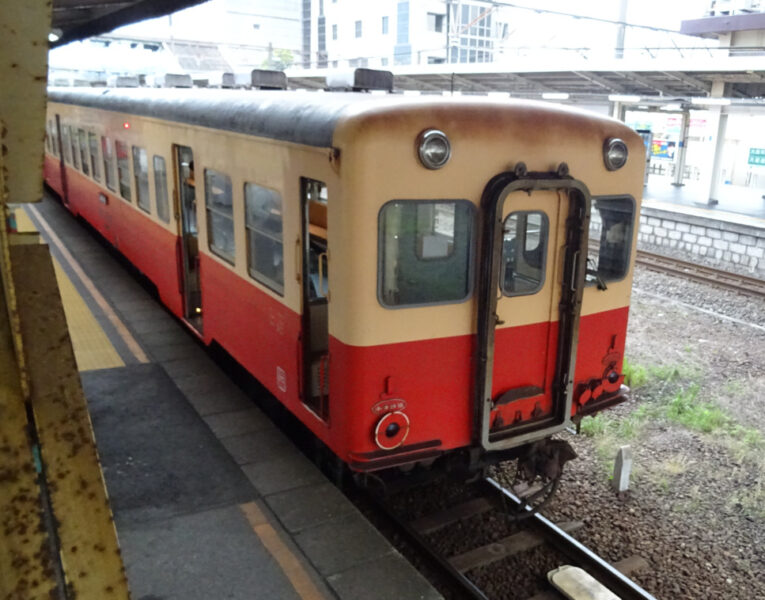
<box><xmin>300</xmin><ymin>177</ymin><xmax>330</xmax><ymax>421</ymax></box>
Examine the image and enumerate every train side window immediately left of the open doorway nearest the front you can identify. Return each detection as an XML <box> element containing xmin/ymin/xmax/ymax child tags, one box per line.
<box><xmin>244</xmin><ymin>182</ymin><xmax>284</xmax><ymax>294</ymax></box>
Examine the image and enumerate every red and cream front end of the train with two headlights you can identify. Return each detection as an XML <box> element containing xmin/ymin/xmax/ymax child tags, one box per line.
<box><xmin>329</xmin><ymin>98</ymin><xmax>644</xmax><ymax>478</ymax></box>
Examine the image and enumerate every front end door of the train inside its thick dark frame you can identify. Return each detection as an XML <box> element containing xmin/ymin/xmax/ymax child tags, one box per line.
<box><xmin>477</xmin><ymin>169</ymin><xmax>589</xmax><ymax>449</ymax></box>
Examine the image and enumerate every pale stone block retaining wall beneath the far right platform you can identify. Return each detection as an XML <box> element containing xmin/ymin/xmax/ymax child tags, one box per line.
<box><xmin>638</xmin><ymin>206</ymin><xmax>765</xmax><ymax>278</ymax></box>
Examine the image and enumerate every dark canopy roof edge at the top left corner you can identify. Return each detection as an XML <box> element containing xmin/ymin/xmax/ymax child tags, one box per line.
<box><xmin>51</xmin><ymin>0</ymin><xmax>205</xmax><ymax>47</ymax></box>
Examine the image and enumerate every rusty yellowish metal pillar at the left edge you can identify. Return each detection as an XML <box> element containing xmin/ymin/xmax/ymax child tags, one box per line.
<box><xmin>0</xmin><ymin>0</ymin><xmax>129</xmax><ymax>600</ymax></box>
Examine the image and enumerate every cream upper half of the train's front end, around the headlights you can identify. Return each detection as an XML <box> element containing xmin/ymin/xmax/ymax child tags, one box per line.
<box><xmin>329</xmin><ymin>100</ymin><xmax>644</xmax><ymax>346</ymax></box>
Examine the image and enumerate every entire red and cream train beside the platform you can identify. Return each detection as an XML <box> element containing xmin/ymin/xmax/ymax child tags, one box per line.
<box><xmin>44</xmin><ymin>69</ymin><xmax>645</xmax><ymax>492</ymax></box>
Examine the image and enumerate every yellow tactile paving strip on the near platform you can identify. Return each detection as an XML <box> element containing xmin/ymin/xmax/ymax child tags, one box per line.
<box><xmin>14</xmin><ymin>207</ymin><xmax>125</xmax><ymax>371</ymax></box>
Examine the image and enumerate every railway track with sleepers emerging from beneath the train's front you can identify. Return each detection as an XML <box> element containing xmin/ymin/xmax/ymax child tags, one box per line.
<box><xmin>372</xmin><ymin>478</ymin><xmax>655</xmax><ymax>600</ymax></box>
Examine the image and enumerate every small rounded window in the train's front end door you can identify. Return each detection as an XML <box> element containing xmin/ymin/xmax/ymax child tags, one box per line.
<box><xmin>500</xmin><ymin>211</ymin><xmax>549</xmax><ymax>296</ymax></box>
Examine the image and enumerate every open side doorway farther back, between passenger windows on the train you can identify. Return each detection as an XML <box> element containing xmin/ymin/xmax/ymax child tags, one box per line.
<box><xmin>173</xmin><ymin>144</ymin><xmax>202</xmax><ymax>333</ymax></box>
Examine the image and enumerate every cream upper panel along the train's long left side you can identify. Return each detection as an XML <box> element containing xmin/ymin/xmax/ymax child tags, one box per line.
<box><xmin>49</xmin><ymin>103</ymin><xmax>337</xmax><ymax>313</ymax></box>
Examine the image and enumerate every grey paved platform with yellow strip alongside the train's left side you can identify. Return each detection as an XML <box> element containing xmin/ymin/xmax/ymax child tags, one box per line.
<box><xmin>16</xmin><ymin>197</ymin><xmax>442</xmax><ymax>600</ymax></box>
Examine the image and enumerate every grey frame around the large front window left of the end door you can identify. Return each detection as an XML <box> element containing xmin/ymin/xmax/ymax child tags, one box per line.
<box><xmin>376</xmin><ymin>198</ymin><xmax>480</xmax><ymax>310</ymax></box>
